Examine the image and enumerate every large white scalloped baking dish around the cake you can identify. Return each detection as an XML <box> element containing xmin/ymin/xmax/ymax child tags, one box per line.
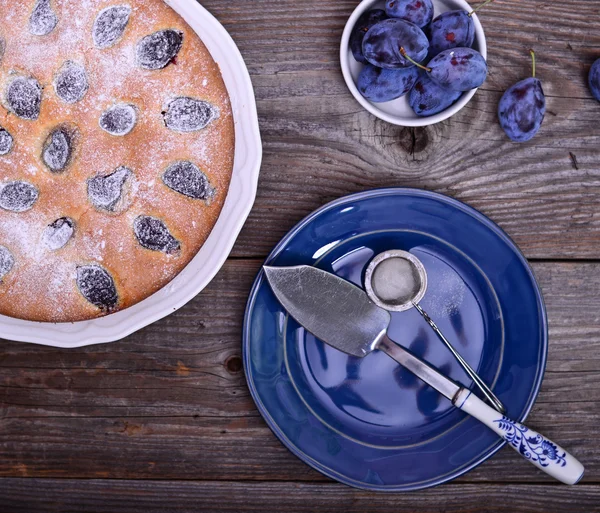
<box><xmin>0</xmin><ymin>0</ymin><xmax>262</xmax><ymax>348</ymax></box>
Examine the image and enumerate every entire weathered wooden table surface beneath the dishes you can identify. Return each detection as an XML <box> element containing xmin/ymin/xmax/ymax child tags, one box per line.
<box><xmin>0</xmin><ymin>0</ymin><xmax>600</xmax><ymax>513</ymax></box>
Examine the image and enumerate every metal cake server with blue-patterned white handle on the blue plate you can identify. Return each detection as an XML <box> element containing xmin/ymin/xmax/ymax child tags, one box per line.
<box><xmin>264</xmin><ymin>266</ymin><xmax>584</xmax><ymax>484</ymax></box>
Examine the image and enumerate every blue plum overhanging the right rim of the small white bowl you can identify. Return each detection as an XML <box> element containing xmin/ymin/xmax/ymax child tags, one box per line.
<box><xmin>427</xmin><ymin>48</ymin><xmax>487</xmax><ymax>91</ymax></box>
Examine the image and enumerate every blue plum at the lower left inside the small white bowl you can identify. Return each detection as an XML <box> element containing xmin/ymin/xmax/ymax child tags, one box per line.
<box><xmin>357</xmin><ymin>64</ymin><xmax>419</xmax><ymax>102</ymax></box>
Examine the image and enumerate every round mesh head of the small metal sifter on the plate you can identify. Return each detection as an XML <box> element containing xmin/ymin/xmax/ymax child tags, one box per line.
<box><xmin>365</xmin><ymin>250</ymin><xmax>427</xmax><ymax>312</ymax></box>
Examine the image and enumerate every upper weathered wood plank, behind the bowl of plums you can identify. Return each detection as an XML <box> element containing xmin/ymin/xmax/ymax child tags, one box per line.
<box><xmin>176</xmin><ymin>0</ymin><xmax>600</xmax><ymax>258</ymax></box>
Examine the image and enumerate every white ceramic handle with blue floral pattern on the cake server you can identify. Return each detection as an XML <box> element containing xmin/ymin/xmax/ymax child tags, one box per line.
<box><xmin>454</xmin><ymin>389</ymin><xmax>585</xmax><ymax>485</ymax></box>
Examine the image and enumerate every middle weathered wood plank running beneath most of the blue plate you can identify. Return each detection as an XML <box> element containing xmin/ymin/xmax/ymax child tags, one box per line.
<box><xmin>0</xmin><ymin>260</ymin><xmax>600</xmax><ymax>482</ymax></box>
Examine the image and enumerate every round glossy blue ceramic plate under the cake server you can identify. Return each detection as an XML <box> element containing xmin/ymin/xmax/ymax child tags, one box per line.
<box><xmin>244</xmin><ymin>189</ymin><xmax>548</xmax><ymax>491</ymax></box>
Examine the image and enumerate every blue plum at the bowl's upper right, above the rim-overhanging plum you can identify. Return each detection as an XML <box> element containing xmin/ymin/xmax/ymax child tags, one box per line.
<box><xmin>429</xmin><ymin>10</ymin><xmax>475</xmax><ymax>57</ymax></box>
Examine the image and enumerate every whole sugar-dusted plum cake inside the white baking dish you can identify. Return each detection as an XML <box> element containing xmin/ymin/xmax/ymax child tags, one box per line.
<box><xmin>0</xmin><ymin>0</ymin><xmax>234</xmax><ymax>322</ymax></box>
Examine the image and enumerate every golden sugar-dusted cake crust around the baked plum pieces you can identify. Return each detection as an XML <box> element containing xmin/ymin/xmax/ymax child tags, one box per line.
<box><xmin>0</xmin><ymin>0</ymin><xmax>234</xmax><ymax>322</ymax></box>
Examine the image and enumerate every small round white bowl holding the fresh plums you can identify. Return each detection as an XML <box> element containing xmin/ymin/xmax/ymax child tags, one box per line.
<box><xmin>340</xmin><ymin>0</ymin><xmax>487</xmax><ymax>126</ymax></box>
